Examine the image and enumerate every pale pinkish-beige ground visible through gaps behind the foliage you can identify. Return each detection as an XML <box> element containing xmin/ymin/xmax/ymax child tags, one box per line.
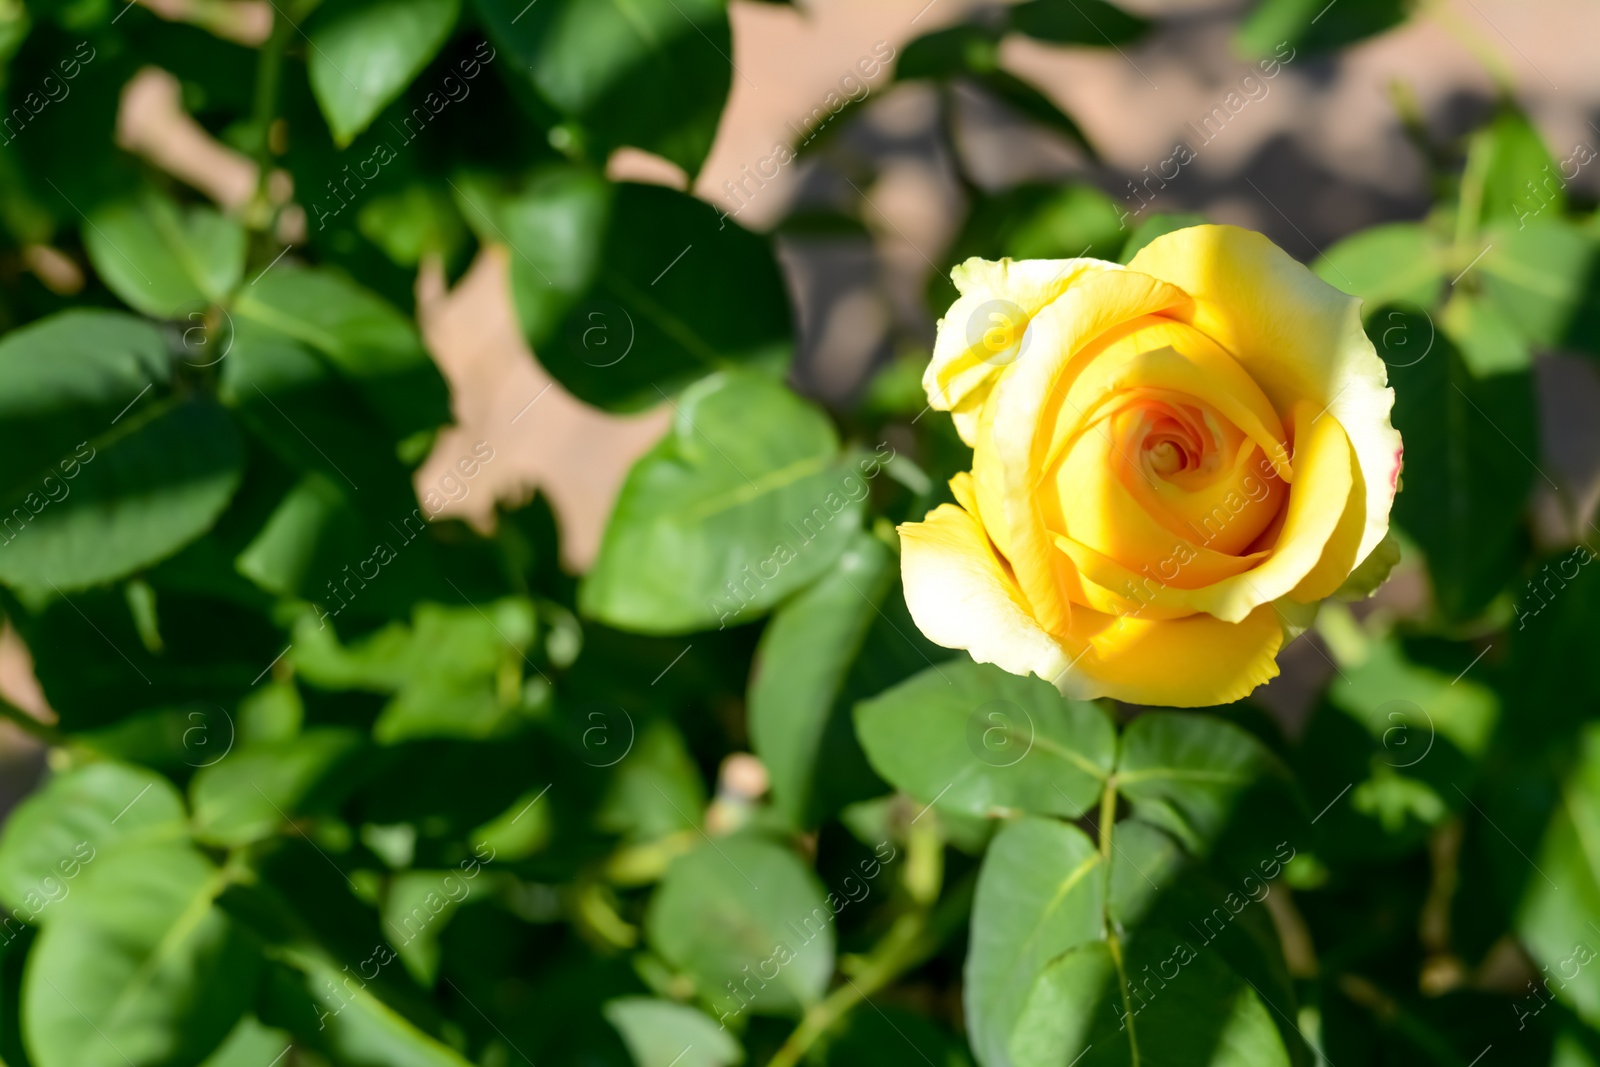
<box><xmin>0</xmin><ymin>0</ymin><xmax>1600</xmax><ymax>767</ymax></box>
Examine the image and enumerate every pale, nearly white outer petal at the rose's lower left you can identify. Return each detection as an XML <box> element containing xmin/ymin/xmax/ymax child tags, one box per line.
<box><xmin>899</xmin><ymin>504</ymin><xmax>1069</xmax><ymax>680</ymax></box>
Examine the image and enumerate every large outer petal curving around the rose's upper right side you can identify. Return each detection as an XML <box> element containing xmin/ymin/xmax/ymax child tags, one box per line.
<box><xmin>1128</xmin><ymin>226</ymin><xmax>1400</xmax><ymax>560</ymax></box>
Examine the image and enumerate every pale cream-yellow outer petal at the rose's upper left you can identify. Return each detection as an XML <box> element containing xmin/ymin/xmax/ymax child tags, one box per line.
<box><xmin>922</xmin><ymin>258</ymin><xmax>1122</xmax><ymax>445</ymax></box>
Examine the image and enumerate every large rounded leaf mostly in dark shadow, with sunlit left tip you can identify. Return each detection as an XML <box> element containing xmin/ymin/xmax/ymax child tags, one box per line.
<box><xmin>480</xmin><ymin>170</ymin><xmax>792</xmax><ymax>411</ymax></box>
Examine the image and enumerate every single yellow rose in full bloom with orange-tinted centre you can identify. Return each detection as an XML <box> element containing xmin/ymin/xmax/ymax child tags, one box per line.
<box><xmin>901</xmin><ymin>226</ymin><xmax>1402</xmax><ymax>707</ymax></box>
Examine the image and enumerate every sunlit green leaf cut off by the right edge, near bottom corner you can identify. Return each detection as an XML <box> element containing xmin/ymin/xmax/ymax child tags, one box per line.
<box><xmin>1515</xmin><ymin>723</ymin><xmax>1600</xmax><ymax>1027</ymax></box>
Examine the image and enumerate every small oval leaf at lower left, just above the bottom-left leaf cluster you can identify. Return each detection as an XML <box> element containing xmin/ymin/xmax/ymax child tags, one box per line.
<box><xmin>189</xmin><ymin>726</ymin><xmax>362</xmax><ymax>848</ymax></box>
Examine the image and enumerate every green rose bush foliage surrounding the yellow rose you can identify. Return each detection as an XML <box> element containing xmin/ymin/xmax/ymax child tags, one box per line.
<box><xmin>0</xmin><ymin>0</ymin><xmax>1600</xmax><ymax>1067</ymax></box>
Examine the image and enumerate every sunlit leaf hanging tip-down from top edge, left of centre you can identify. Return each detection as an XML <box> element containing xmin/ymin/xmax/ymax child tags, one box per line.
<box><xmin>306</xmin><ymin>0</ymin><xmax>461</xmax><ymax>149</ymax></box>
